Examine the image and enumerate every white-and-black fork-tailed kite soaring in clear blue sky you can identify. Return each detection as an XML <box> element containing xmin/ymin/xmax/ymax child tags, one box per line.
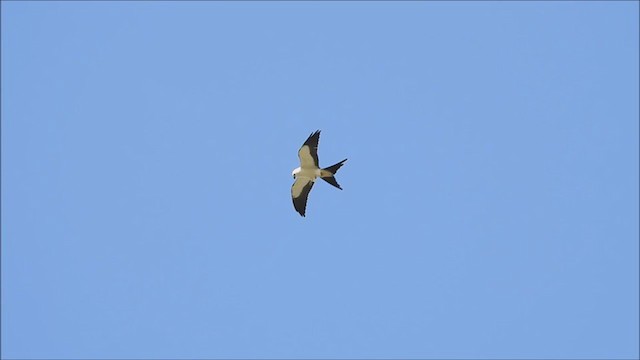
<box><xmin>291</xmin><ymin>130</ymin><xmax>347</xmax><ymax>216</ymax></box>
